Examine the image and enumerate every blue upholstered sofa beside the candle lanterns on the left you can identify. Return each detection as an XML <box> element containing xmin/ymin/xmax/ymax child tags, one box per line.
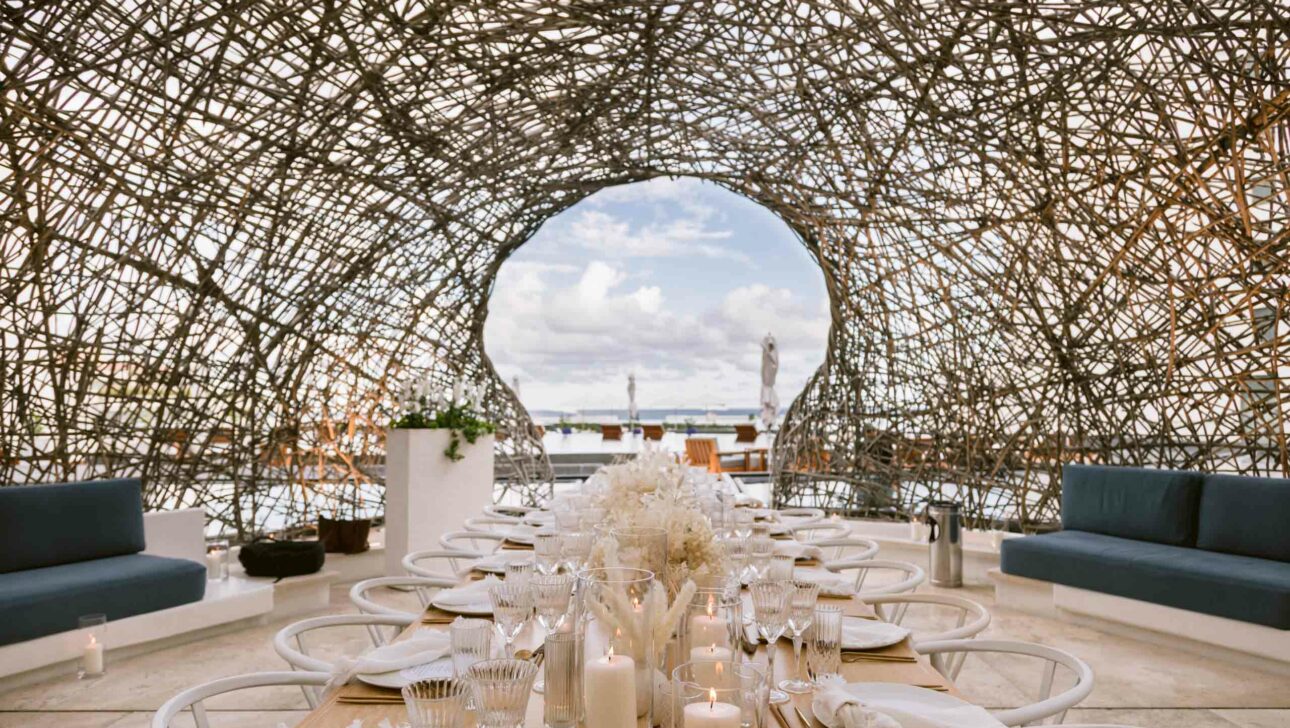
<box><xmin>0</xmin><ymin>479</ymin><xmax>206</xmax><ymax>645</ymax></box>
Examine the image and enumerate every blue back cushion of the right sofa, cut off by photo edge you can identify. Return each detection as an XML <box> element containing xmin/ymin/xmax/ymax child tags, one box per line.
<box><xmin>1196</xmin><ymin>475</ymin><xmax>1290</xmax><ymax>561</ymax></box>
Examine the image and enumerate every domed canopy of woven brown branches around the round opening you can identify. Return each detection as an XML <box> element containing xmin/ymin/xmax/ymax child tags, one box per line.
<box><xmin>0</xmin><ymin>0</ymin><xmax>1290</xmax><ymax>534</ymax></box>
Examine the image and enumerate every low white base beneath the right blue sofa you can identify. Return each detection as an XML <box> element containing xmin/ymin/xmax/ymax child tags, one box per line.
<box><xmin>989</xmin><ymin>569</ymin><xmax>1290</xmax><ymax>675</ymax></box>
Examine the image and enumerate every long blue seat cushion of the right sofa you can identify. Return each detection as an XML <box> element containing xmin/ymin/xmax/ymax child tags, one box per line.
<box><xmin>1000</xmin><ymin>531</ymin><xmax>1290</xmax><ymax>630</ymax></box>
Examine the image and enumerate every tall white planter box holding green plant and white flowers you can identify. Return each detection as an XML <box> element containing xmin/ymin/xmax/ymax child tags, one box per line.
<box><xmin>386</xmin><ymin>430</ymin><xmax>493</xmax><ymax>576</ymax></box>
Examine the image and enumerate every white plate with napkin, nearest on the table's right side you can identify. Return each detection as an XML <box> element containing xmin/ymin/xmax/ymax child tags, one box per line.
<box><xmin>811</xmin><ymin>675</ymin><xmax>1004</xmax><ymax>728</ymax></box>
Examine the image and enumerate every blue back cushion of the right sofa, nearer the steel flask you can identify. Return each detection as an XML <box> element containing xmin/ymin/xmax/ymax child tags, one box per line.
<box><xmin>1062</xmin><ymin>465</ymin><xmax>1202</xmax><ymax>546</ymax></box>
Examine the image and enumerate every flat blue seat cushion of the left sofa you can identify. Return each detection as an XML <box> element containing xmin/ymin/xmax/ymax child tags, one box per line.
<box><xmin>0</xmin><ymin>554</ymin><xmax>206</xmax><ymax>644</ymax></box>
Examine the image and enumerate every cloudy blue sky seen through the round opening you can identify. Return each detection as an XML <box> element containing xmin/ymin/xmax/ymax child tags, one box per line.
<box><xmin>484</xmin><ymin>178</ymin><xmax>828</xmax><ymax>410</ymax></box>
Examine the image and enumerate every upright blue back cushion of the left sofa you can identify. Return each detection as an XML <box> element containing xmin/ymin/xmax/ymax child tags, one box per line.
<box><xmin>0</xmin><ymin>478</ymin><xmax>144</xmax><ymax>573</ymax></box>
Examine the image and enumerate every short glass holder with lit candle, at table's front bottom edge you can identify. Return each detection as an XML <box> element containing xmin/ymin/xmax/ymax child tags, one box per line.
<box><xmin>672</xmin><ymin>661</ymin><xmax>768</xmax><ymax>728</ymax></box>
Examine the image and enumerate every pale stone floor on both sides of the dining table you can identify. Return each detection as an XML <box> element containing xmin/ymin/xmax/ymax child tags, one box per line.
<box><xmin>0</xmin><ymin>578</ymin><xmax>1290</xmax><ymax>728</ymax></box>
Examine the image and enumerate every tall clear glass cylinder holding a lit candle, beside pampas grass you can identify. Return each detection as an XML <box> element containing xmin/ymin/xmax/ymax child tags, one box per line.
<box><xmin>574</xmin><ymin>567</ymin><xmax>662</xmax><ymax>728</ymax></box>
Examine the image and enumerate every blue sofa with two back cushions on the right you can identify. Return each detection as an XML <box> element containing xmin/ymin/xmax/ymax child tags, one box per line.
<box><xmin>1000</xmin><ymin>465</ymin><xmax>1290</xmax><ymax>630</ymax></box>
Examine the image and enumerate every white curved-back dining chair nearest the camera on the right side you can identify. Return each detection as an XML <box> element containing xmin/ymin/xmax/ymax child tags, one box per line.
<box><xmin>918</xmin><ymin>639</ymin><xmax>1093</xmax><ymax>725</ymax></box>
